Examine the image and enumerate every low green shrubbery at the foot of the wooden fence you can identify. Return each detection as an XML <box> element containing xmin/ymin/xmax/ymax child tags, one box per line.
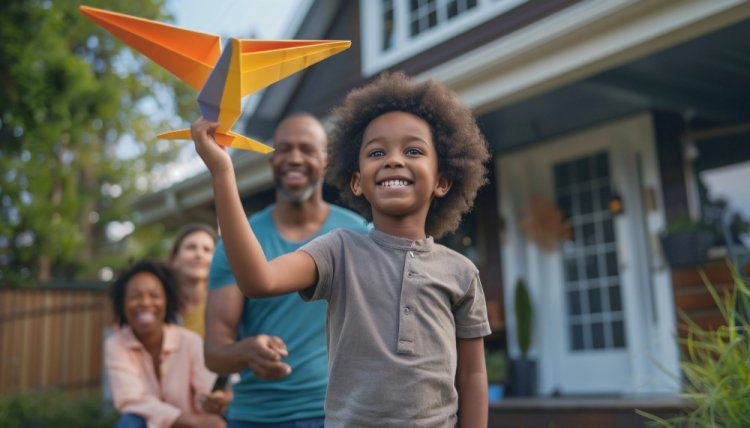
<box><xmin>0</xmin><ymin>392</ymin><xmax>117</xmax><ymax>428</ymax></box>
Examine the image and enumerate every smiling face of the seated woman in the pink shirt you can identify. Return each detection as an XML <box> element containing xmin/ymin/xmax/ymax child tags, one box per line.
<box><xmin>124</xmin><ymin>272</ymin><xmax>167</xmax><ymax>337</ymax></box>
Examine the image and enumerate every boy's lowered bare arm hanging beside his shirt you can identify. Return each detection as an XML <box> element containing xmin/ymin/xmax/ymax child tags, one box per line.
<box><xmin>456</xmin><ymin>337</ymin><xmax>488</xmax><ymax>428</ymax></box>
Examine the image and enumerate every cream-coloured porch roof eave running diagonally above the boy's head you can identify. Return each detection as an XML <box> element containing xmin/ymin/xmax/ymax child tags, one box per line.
<box><xmin>419</xmin><ymin>0</ymin><xmax>750</xmax><ymax>114</ymax></box>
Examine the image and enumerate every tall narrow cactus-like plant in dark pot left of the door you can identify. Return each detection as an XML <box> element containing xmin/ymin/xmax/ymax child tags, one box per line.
<box><xmin>510</xmin><ymin>279</ymin><xmax>536</xmax><ymax>397</ymax></box>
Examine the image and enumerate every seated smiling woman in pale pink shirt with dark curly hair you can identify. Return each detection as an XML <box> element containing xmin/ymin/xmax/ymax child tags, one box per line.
<box><xmin>105</xmin><ymin>261</ymin><xmax>229</xmax><ymax>428</ymax></box>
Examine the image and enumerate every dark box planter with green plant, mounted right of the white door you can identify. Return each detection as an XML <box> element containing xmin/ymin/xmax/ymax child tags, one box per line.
<box><xmin>661</xmin><ymin>217</ymin><xmax>715</xmax><ymax>268</ymax></box>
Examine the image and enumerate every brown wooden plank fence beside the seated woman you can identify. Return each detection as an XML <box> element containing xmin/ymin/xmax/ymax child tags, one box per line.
<box><xmin>0</xmin><ymin>283</ymin><xmax>112</xmax><ymax>395</ymax></box>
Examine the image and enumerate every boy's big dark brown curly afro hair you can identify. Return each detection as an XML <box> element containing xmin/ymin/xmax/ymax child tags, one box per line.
<box><xmin>327</xmin><ymin>72</ymin><xmax>490</xmax><ymax>238</ymax></box>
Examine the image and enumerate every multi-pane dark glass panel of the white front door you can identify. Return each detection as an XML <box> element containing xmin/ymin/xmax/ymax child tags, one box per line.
<box><xmin>554</xmin><ymin>152</ymin><xmax>626</xmax><ymax>351</ymax></box>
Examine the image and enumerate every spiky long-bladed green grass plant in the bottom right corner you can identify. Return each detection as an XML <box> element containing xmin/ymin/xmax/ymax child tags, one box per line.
<box><xmin>638</xmin><ymin>269</ymin><xmax>750</xmax><ymax>428</ymax></box>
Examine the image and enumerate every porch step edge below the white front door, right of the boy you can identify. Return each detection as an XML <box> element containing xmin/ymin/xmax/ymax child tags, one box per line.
<box><xmin>488</xmin><ymin>396</ymin><xmax>688</xmax><ymax>428</ymax></box>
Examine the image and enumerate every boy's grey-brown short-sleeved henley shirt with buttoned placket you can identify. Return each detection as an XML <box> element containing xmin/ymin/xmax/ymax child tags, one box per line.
<box><xmin>300</xmin><ymin>229</ymin><xmax>490</xmax><ymax>428</ymax></box>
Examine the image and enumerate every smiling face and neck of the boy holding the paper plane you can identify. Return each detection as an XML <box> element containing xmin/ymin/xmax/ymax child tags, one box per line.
<box><xmin>351</xmin><ymin>111</ymin><xmax>451</xmax><ymax>239</ymax></box>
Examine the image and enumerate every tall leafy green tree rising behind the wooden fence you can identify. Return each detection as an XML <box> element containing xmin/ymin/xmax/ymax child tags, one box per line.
<box><xmin>0</xmin><ymin>0</ymin><xmax>196</xmax><ymax>284</ymax></box>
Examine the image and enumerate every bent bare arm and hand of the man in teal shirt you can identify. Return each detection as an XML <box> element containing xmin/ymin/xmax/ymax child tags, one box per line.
<box><xmin>204</xmin><ymin>285</ymin><xmax>291</xmax><ymax>380</ymax></box>
